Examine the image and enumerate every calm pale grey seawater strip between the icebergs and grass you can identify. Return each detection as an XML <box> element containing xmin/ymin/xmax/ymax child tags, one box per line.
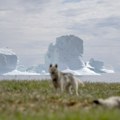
<box><xmin>0</xmin><ymin>73</ymin><xmax>120</xmax><ymax>83</ymax></box>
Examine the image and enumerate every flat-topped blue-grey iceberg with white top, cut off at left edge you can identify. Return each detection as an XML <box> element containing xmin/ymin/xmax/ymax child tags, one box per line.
<box><xmin>0</xmin><ymin>48</ymin><xmax>17</xmax><ymax>74</ymax></box>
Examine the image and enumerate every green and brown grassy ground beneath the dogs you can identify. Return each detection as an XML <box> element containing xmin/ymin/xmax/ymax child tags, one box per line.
<box><xmin>0</xmin><ymin>81</ymin><xmax>120</xmax><ymax>120</ymax></box>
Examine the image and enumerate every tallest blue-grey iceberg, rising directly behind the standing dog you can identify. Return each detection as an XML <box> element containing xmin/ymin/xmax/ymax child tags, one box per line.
<box><xmin>45</xmin><ymin>35</ymin><xmax>84</xmax><ymax>70</ymax></box>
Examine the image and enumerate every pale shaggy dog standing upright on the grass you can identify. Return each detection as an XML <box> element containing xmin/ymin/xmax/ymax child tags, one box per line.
<box><xmin>49</xmin><ymin>64</ymin><xmax>84</xmax><ymax>95</ymax></box>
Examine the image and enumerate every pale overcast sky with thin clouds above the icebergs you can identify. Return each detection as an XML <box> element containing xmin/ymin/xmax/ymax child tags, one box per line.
<box><xmin>0</xmin><ymin>0</ymin><xmax>120</xmax><ymax>70</ymax></box>
